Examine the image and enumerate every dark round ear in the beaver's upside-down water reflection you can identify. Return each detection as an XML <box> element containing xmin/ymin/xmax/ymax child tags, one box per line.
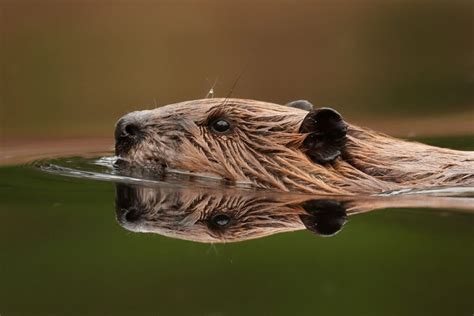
<box><xmin>300</xmin><ymin>200</ymin><xmax>347</xmax><ymax>236</ymax></box>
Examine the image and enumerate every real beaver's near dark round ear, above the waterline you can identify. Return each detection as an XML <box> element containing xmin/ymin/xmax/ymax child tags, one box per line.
<box><xmin>299</xmin><ymin>108</ymin><xmax>347</xmax><ymax>164</ymax></box>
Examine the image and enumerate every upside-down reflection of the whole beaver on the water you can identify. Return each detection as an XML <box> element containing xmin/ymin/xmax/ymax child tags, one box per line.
<box><xmin>115</xmin><ymin>183</ymin><xmax>473</xmax><ymax>243</ymax></box>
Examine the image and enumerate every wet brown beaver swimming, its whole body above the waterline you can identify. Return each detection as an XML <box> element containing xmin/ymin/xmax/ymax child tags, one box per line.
<box><xmin>115</xmin><ymin>99</ymin><xmax>474</xmax><ymax>194</ymax></box>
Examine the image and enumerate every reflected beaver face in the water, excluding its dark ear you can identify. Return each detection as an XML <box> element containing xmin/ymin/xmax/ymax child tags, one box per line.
<box><xmin>116</xmin><ymin>184</ymin><xmax>304</xmax><ymax>242</ymax></box>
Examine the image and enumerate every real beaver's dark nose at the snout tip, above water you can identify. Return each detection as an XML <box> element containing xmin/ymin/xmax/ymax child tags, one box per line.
<box><xmin>115</xmin><ymin>112</ymin><xmax>144</xmax><ymax>156</ymax></box>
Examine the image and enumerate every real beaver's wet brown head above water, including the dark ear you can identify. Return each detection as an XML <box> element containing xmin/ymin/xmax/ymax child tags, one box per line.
<box><xmin>115</xmin><ymin>99</ymin><xmax>362</xmax><ymax>191</ymax></box>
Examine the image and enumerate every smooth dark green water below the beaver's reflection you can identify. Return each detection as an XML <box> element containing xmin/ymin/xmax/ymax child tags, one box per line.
<box><xmin>0</xmin><ymin>138</ymin><xmax>474</xmax><ymax>316</ymax></box>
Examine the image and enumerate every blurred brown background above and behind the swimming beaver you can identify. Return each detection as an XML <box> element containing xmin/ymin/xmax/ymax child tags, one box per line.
<box><xmin>0</xmin><ymin>0</ymin><xmax>474</xmax><ymax>142</ymax></box>
